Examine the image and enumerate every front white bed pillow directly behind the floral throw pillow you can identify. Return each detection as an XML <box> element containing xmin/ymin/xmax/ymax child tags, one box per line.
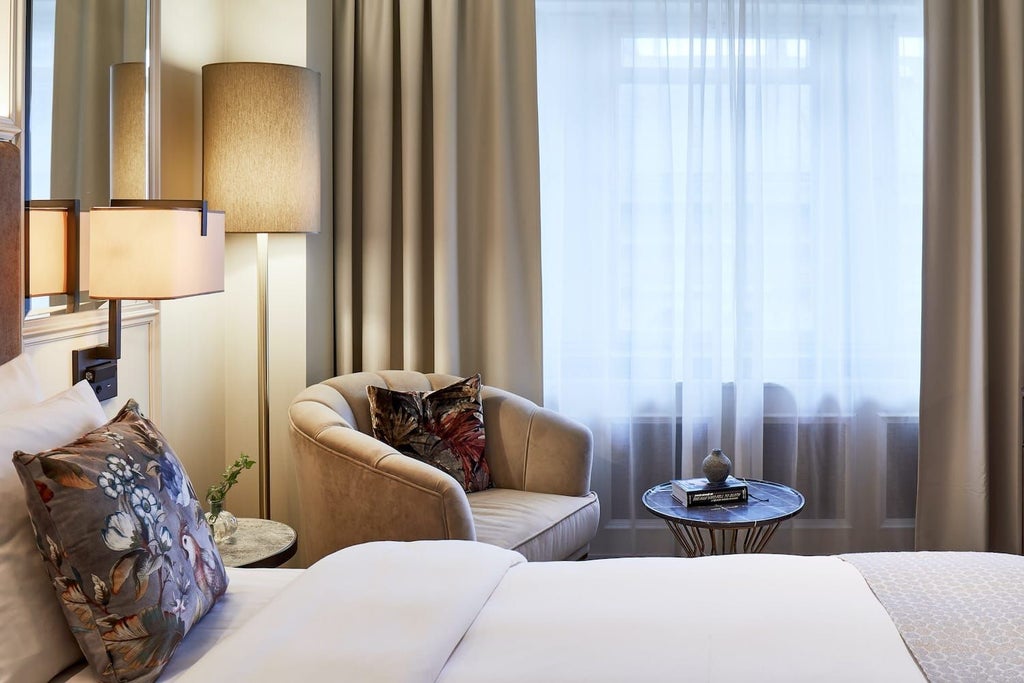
<box><xmin>0</xmin><ymin>382</ymin><xmax>106</xmax><ymax>683</ymax></box>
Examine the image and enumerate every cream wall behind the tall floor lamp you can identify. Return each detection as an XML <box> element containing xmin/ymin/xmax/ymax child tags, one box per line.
<box><xmin>161</xmin><ymin>0</ymin><xmax>323</xmax><ymax>561</ymax></box>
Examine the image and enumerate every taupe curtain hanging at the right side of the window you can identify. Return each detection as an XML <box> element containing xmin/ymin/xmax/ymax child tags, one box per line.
<box><xmin>916</xmin><ymin>0</ymin><xmax>1024</xmax><ymax>553</ymax></box>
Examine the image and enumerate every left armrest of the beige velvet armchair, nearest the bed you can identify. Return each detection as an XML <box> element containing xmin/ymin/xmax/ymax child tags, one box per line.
<box><xmin>289</xmin><ymin>385</ymin><xmax>476</xmax><ymax>563</ymax></box>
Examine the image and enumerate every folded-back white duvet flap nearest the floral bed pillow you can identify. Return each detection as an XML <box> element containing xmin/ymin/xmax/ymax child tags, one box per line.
<box><xmin>178</xmin><ymin>541</ymin><xmax>525</xmax><ymax>683</ymax></box>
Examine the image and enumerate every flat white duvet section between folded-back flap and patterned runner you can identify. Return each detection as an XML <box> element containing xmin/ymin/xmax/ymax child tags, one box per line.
<box><xmin>438</xmin><ymin>555</ymin><xmax>925</xmax><ymax>683</ymax></box>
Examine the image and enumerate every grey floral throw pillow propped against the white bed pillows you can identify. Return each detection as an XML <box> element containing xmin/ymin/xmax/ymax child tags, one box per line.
<box><xmin>14</xmin><ymin>400</ymin><xmax>227</xmax><ymax>681</ymax></box>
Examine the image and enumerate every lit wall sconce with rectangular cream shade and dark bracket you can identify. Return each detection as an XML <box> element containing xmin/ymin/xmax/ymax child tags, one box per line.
<box><xmin>72</xmin><ymin>200</ymin><xmax>224</xmax><ymax>400</ymax></box>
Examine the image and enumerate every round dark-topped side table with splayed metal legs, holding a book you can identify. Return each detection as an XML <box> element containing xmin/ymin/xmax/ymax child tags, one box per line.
<box><xmin>643</xmin><ymin>479</ymin><xmax>804</xmax><ymax>557</ymax></box>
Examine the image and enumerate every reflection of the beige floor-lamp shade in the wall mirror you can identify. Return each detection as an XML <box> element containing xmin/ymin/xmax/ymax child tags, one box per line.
<box><xmin>111</xmin><ymin>61</ymin><xmax>147</xmax><ymax>199</ymax></box>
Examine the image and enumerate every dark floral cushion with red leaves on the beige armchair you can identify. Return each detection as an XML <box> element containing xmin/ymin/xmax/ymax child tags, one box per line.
<box><xmin>367</xmin><ymin>375</ymin><xmax>490</xmax><ymax>494</ymax></box>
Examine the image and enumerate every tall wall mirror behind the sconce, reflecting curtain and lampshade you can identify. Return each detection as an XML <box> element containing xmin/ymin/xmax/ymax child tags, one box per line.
<box><xmin>25</xmin><ymin>0</ymin><xmax>151</xmax><ymax>315</ymax></box>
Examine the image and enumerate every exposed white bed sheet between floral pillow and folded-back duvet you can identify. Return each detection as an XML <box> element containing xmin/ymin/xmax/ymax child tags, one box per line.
<box><xmin>51</xmin><ymin>567</ymin><xmax>303</xmax><ymax>683</ymax></box>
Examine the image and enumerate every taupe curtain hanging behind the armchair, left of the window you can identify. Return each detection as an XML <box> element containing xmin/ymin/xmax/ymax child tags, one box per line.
<box><xmin>334</xmin><ymin>0</ymin><xmax>542</xmax><ymax>400</ymax></box>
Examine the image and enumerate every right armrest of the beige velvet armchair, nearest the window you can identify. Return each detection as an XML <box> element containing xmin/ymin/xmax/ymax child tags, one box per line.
<box><xmin>482</xmin><ymin>387</ymin><xmax>594</xmax><ymax>496</ymax></box>
